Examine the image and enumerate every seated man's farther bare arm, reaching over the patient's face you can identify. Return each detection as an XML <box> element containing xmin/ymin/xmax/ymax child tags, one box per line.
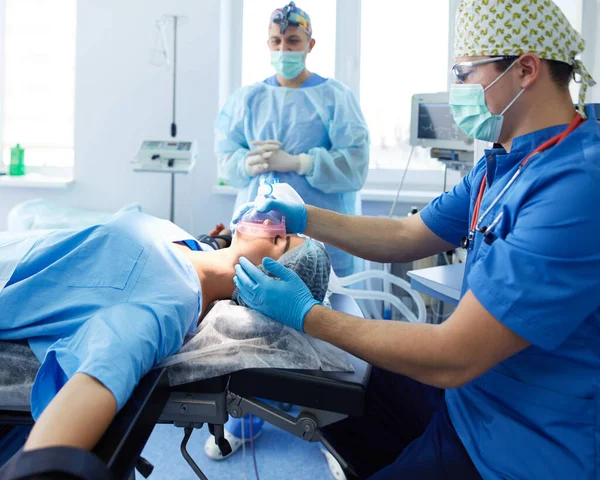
<box><xmin>305</xmin><ymin>205</ymin><xmax>454</xmax><ymax>263</ymax></box>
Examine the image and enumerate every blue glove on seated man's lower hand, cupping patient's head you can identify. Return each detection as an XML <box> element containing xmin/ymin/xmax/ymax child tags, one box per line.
<box><xmin>233</xmin><ymin>257</ymin><xmax>319</xmax><ymax>332</ymax></box>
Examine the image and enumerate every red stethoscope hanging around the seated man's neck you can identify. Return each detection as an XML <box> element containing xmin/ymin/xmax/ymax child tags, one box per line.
<box><xmin>461</xmin><ymin>113</ymin><xmax>585</xmax><ymax>250</ymax></box>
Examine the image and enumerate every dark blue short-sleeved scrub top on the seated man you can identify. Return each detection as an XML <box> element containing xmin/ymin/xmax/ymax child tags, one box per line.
<box><xmin>421</xmin><ymin>114</ymin><xmax>600</xmax><ymax>479</ymax></box>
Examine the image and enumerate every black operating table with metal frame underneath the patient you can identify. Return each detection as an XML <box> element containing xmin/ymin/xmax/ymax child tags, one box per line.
<box><xmin>0</xmin><ymin>294</ymin><xmax>370</xmax><ymax>479</ymax></box>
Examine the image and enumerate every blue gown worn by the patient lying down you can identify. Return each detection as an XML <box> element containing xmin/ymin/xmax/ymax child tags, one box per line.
<box><xmin>0</xmin><ymin>212</ymin><xmax>202</xmax><ymax>418</ymax></box>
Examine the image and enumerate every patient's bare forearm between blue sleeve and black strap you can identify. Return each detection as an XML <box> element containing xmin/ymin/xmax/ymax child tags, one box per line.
<box><xmin>24</xmin><ymin>373</ymin><xmax>117</xmax><ymax>450</ymax></box>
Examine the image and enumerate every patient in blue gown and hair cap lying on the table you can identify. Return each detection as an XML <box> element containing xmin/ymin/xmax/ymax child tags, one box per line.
<box><xmin>0</xmin><ymin>213</ymin><xmax>329</xmax><ymax>456</ymax></box>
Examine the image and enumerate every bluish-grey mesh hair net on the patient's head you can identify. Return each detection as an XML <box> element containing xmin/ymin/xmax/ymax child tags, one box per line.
<box><xmin>231</xmin><ymin>239</ymin><xmax>331</xmax><ymax>305</ymax></box>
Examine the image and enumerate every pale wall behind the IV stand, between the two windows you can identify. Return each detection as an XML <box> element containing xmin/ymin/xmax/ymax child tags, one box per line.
<box><xmin>0</xmin><ymin>0</ymin><xmax>233</xmax><ymax>233</ymax></box>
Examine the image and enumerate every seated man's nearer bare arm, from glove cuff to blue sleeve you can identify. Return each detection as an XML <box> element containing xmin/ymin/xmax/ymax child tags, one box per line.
<box><xmin>304</xmin><ymin>290</ymin><xmax>530</xmax><ymax>388</ymax></box>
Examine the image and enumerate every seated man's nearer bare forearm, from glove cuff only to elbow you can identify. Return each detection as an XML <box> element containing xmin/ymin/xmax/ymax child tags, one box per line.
<box><xmin>304</xmin><ymin>306</ymin><xmax>465</xmax><ymax>388</ymax></box>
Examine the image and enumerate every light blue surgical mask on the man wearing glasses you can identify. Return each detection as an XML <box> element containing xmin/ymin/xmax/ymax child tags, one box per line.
<box><xmin>449</xmin><ymin>62</ymin><xmax>525</xmax><ymax>143</ymax></box>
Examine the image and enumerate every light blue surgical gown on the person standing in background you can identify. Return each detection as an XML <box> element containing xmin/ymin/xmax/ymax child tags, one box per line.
<box><xmin>215</xmin><ymin>74</ymin><xmax>369</xmax><ymax>276</ymax></box>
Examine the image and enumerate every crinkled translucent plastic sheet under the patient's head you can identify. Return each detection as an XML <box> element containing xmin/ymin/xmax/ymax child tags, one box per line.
<box><xmin>160</xmin><ymin>300</ymin><xmax>354</xmax><ymax>386</ymax></box>
